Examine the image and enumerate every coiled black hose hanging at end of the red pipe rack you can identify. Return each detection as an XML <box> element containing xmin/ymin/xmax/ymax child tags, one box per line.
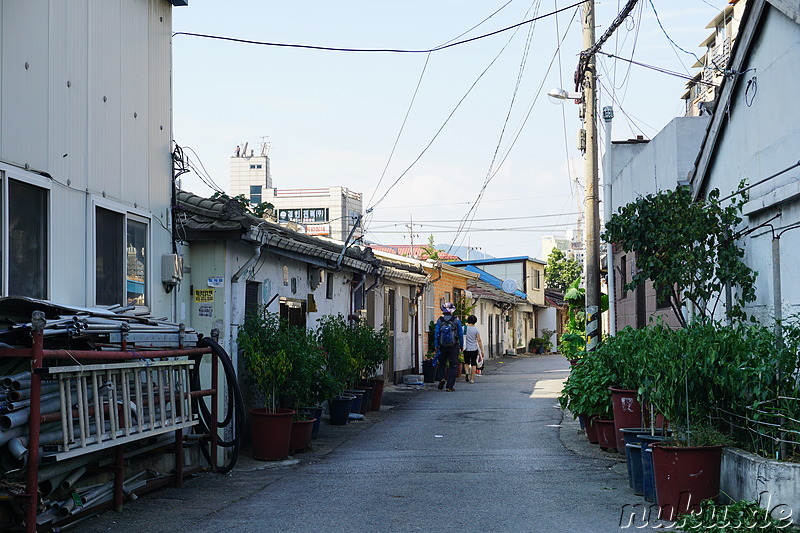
<box><xmin>191</xmin><ymin>337</ymin><xmax>244</xmax><ymax>474</ymax></box>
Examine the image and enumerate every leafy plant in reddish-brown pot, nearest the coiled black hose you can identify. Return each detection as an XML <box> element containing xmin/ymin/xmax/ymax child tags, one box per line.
<box><xmin>238</xmin><ymin>307</ymin><xmax>294</xmax><ymax>460</ymax></box>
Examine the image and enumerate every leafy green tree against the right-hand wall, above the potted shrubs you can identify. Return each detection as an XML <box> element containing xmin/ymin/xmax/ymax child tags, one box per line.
<box><xmin>602</xmin><ymin>187</ymin><xmax>756</xmax><ymax>327</ymax></box>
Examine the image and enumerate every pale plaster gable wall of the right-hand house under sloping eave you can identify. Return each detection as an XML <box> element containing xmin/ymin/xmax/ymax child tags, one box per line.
<box><xmin>700</xmin><ymin>5</ymin><xmax>800</xmax><ymax>323</ymax></box>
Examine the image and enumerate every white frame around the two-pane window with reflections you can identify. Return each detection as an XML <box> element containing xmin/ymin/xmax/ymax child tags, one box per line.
<box><xmin>87</xmin><ymin>197</ymin><xmax>153</xmax><ymax>311</ymax></box>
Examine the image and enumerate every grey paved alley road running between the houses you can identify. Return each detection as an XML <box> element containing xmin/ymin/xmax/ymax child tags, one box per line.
<box><xmin>74</xmin><ymin>356</ymin><xmax>642</xmax><ymax>533</ymax></box>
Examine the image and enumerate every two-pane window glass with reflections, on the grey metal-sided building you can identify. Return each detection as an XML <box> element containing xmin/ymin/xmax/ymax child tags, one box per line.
<box><xmin>95</xmin><ymin>207</ymin><xmax>148</xmax><ymax>307</ymax></box>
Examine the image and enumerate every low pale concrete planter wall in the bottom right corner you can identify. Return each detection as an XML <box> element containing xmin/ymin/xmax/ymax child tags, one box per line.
<box><xmin>720</xmin><ymin>448</ymin><xmax>800</xmax><ymax>525</ymax></box>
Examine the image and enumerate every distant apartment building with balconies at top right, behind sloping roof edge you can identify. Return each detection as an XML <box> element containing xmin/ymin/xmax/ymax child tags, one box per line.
<box><xmin>681</xmin><ymin>0</ymin><xmax>747</xmax><ymax>117</ymax></box>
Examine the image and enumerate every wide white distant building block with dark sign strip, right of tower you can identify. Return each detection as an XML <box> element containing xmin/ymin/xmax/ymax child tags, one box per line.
<box><xmin>263</xmin><ymin>187</ymin><xmax>363</xmax><ymax>241</ymax></box>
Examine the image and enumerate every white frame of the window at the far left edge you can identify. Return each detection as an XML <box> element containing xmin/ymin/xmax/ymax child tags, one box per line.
<box><xmin>0</xmin><ymin>162</ymin><xmax>53</xmax><ymax>300</ymax></box>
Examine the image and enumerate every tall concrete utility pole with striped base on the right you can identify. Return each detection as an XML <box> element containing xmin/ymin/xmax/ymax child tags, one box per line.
<box><xmin>576</xmin><ymin>0</ymin><xmax>602</xmax><ymax>351</ymax></box>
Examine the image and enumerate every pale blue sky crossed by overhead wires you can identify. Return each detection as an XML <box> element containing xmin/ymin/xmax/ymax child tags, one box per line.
<box><xmin>172</xmin><ymin>0</ymin><xmax>727</xmax><ymax>260</ymax></box>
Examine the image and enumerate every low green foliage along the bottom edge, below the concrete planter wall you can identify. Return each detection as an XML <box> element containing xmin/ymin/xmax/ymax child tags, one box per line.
<box><xmin>676</xmin><ymin>500</ymin><xmax>791</xmax><ymax>533</ymax></box>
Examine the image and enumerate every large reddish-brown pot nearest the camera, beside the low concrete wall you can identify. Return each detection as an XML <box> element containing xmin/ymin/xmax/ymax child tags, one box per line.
<box><xmin>652</xmin><ymin>443</ymin><xmax>723</xmax><ymax>522</ymax></box>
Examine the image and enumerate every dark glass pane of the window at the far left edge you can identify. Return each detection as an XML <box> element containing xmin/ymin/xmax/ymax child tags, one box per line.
<box><xmin>3</xmin><ymin>179</ymin><xmax>49</xmax><ymax>298</ymax></box>
